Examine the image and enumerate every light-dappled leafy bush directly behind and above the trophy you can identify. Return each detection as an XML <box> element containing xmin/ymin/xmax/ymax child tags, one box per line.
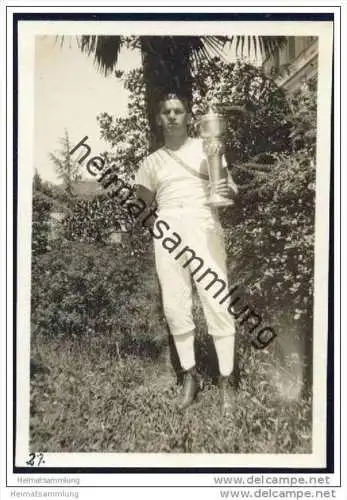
<box><xmin>192</xmin><ymin>58</ymin><xmax>291</xmax><ymax>163</ymax></box>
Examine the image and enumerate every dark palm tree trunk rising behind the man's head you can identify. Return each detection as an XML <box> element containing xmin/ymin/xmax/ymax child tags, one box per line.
<box><xmin>141</xmin><ymin>36</ymin><xmax>196</xmax><ymax>151</ymax></box>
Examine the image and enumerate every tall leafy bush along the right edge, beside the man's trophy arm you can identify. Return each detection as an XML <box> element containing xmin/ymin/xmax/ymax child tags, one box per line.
<box><xmin>218</xmin><ymin>81</ymin><xmax>316</xmax><ymax>388</ymax></box>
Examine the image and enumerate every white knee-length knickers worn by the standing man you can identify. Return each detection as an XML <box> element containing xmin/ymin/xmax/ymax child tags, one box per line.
<box><xmin>153</xmin><ymin>211</ymin><xmax>235</xmax><ymax>336</ymax></box>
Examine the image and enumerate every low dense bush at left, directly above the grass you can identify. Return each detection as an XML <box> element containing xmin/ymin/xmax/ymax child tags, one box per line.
<box><xmin>32</xmin><ymin>242</ymin><xmax>166</xmax><ymax>352</ymax></box>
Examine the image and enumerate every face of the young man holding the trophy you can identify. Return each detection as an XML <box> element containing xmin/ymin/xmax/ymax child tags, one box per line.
<box><xmin>157</xmin><ymin>99</ymin><xmax>189</xmax><ymax>136</ymax></box>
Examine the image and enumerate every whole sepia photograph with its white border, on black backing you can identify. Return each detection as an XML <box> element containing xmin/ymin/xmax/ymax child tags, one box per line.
<box><xmin>17</xmin><ymin>21</ymin><xmax>332</xmax><ymax>467</ymax></box>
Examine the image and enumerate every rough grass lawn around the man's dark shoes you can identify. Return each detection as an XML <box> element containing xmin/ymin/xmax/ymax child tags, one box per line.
<box><xmin>30</xmin><ymin>338</ymin><xmax>311</xmax><ymax>453</ymax></box>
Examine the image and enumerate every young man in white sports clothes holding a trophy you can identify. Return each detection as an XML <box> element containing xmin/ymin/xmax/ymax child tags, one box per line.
<box><xmin>135</xmin><ymin>94</ymin><xmax>237</xmax><ymax>414</ymax></box>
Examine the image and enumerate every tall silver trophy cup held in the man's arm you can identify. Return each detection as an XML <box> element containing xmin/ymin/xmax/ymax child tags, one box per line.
<box><xmin>199</xmin><ymin>109</ymin><xmax>234</xmax><ymax>207</ymax></box>
